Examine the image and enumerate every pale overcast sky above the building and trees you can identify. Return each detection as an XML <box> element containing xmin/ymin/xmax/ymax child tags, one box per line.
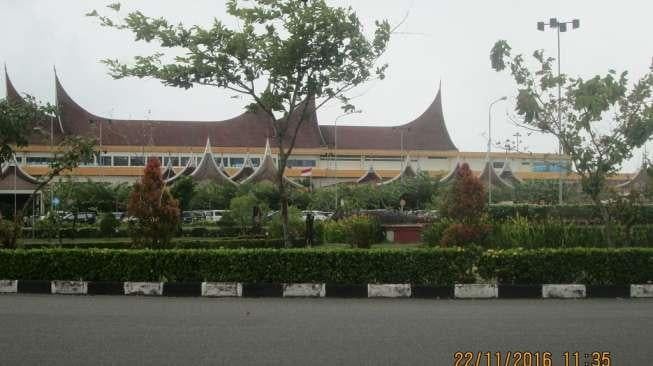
<box><xmin>0</xmin><ymin>0</ymin><xmax>653</xmax><ymax>172</ymax></box>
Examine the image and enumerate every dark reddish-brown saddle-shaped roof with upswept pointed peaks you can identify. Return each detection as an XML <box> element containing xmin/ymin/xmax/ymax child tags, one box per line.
<box><xmin>7</xmin><ymin>70</ymin><xmax>457</xmax><ymax>151</ymax></box>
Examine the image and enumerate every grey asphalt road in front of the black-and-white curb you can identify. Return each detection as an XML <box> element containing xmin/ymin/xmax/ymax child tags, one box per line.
<box><xmin>0</xmin><ymin>295</ymin><xmax>653</xmax><ymax>366</ymax></box>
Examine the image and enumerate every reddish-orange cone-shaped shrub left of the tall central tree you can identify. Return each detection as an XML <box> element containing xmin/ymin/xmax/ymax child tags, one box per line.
<box><xmin>127</xmin><ymin>158</ymin><xmax>179</xmax><ymax>247</ymax></box>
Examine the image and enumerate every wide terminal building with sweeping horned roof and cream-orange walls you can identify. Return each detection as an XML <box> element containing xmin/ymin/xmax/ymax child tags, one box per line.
<box><xmin>5</xmin><ymin>70</ymin><xmax>572</xmax><ymax>187</ymax></box>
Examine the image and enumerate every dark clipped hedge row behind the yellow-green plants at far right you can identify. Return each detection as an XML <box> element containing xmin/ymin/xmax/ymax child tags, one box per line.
<box><xmin>489</xmin><ymin>204</ymin><xmax>653</xmax><ymax>224</ymax></box>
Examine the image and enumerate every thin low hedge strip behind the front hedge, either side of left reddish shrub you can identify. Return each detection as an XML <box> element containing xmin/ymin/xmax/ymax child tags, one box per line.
<box><xmin>21</xmin><ymin>238</ymin><xmax>283</xmax><ymax>249</ymax></box>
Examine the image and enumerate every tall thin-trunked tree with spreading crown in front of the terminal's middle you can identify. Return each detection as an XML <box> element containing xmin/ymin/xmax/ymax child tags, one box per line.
<box><xmin>87</xmin><ymin>0</ymin><xmax>392</xmax><ymax>246</ymax></box>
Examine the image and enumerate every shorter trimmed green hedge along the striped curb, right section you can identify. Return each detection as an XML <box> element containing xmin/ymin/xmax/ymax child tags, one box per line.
<box><xmin>478</xmin><ymin>248</ymin><xmax>653</xmax><ymax>285</ymax></box>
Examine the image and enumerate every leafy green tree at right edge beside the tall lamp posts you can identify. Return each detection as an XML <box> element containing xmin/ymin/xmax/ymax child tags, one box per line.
<box><xmin>490</xmin><ymin>40</ymin><xmax>653</xmax><ymax>244</ymax></box>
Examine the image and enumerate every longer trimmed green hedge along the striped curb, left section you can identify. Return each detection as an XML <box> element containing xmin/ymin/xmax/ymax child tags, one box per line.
<box><xmin>0</xmin><ymin>248</ymin><xmax>480</xmax><ymax>285</ymax></box>
